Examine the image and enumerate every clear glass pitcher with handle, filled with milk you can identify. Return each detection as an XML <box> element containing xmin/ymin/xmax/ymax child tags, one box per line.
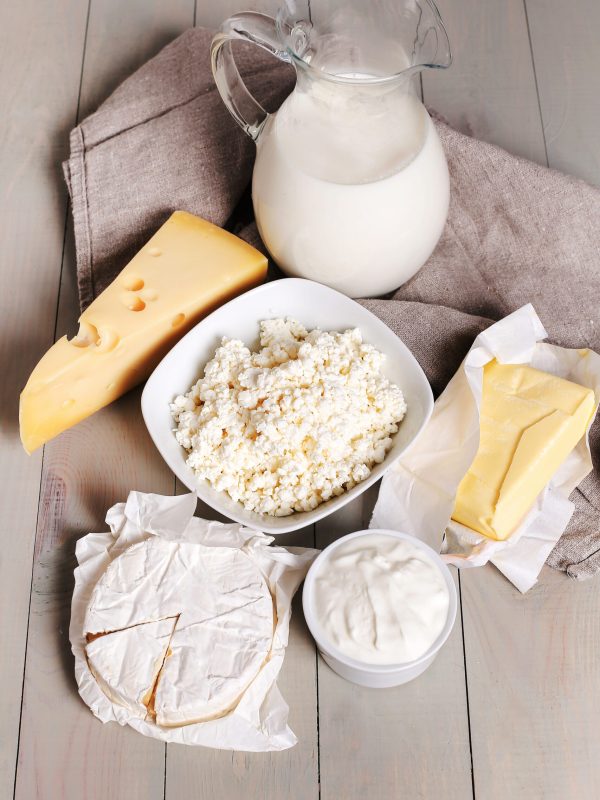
<box><xmin>212</xmin><ymin>0</ymin><xmax>451</xmax><ymax>297</ymax></box>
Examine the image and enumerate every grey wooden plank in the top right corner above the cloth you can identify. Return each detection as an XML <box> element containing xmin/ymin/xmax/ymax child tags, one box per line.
<box><xmin>525</xmin><ymin>0</ymin><xmax>600</xmax><ymax>185</ymax></box>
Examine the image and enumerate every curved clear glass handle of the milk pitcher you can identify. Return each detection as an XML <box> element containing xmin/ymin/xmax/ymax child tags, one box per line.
<box><xmin>210</xmin><ymin>11</ymin><xmax>291</xmax><ymax>141</ymax></box>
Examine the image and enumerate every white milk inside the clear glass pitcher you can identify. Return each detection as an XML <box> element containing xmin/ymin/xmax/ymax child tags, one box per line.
<box><xmin>252</xmin><ymin>81</ymin><xmax>449</xmax><ymax>297</ymax></box>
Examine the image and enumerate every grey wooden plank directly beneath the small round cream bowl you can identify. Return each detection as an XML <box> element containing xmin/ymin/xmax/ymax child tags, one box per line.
<box><xmin>316</xmin><ymin>486</ymin><xmax>472</xmax><ymax>800</ymax></box>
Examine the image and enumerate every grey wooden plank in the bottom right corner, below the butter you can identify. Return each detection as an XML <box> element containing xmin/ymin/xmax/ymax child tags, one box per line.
<box><xmin>462</xmin><ymin>567</ymin><xmax>600</xmax><ymax>800</ymax></box>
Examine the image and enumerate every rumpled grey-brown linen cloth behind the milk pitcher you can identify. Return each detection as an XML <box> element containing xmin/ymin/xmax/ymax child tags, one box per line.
<box><xmin>64</xmin><ymin>29</ymin><xmax>600</xmax><ymax>578</ymax></box>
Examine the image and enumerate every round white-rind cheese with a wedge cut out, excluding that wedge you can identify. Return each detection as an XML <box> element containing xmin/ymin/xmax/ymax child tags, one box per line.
<box><xmin>84</xmin><ymin>537</ymin><xmax>274</xmax><ymax>725</ymax></box>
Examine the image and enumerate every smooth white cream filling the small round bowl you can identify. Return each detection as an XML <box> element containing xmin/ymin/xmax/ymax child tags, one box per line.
<box><xmin>313</xmin><ymin>533</ymin><xmax>450</xmax><ymax>665</ymax></box>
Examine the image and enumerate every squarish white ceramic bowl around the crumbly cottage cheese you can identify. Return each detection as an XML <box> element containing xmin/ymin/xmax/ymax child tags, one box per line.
<box><xmin>142</xmin><ymin>278</ymin><xmax>433</xmax><ymax>533</ymax></box>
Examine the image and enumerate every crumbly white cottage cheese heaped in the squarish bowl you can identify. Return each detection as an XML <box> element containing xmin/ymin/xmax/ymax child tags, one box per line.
<box><xmin>171</xmin><ymin>319</ymin><xmax>406</xmax><ymax>516</ymax></box>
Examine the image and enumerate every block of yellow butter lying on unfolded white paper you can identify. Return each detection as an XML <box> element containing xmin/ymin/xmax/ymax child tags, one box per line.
<box><xmin>452</xmin><ymin>360</ymin><xmax>595</xmax><ymax>540</ymax></box>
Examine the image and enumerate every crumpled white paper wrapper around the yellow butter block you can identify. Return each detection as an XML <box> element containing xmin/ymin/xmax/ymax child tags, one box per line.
<box><xmin>370</xmin><ymin>304</ymin><xmax>600</xmax><ymax>592</ymax></box>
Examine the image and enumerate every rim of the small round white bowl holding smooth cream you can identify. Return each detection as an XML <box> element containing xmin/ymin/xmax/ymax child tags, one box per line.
<box><xmin>302</xmin><ymin>528</ymin><xmax>458</xmax><ymax>675</ymax></box>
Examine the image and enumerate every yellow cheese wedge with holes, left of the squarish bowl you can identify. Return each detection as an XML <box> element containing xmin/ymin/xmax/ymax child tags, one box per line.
<box><xmin>19</xmin><ymin>211</ymin><xmax>267</xmax><ymax>452</ymax></box>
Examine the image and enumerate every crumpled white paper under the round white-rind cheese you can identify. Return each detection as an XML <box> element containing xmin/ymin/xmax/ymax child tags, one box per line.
<box><xmin>69</xmin><ymin>492</ymin><xmax>319</xmax><ymax>752</ymax></box>
